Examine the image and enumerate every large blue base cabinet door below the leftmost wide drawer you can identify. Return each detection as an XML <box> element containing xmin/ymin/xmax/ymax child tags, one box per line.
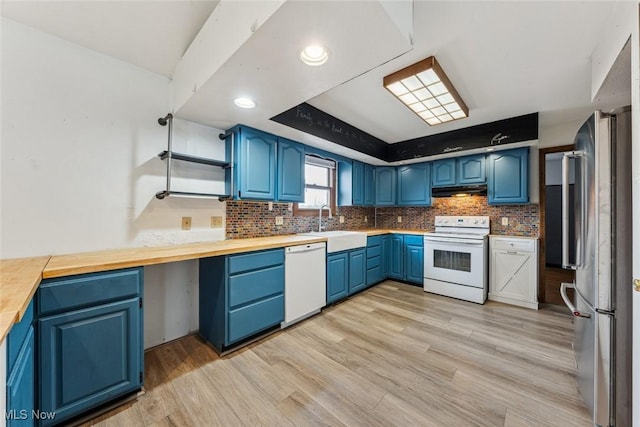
<box><xmin>38</xmin><ymin>298</ymin><xmax>143</xmax><ymax>426</ymax></box>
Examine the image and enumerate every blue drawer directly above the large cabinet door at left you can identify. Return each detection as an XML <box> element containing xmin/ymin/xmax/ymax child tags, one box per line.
<box><xmin>38</xmin><ymin>268</ymin><xmax>143</xmax><ymax>315</ymax></box>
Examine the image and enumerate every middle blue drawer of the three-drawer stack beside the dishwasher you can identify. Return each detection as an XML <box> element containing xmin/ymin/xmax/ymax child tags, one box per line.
<box><xmin>229</xmin><ymin>265</ymin><xmax>284</xmax><ymax>308</ymax></box>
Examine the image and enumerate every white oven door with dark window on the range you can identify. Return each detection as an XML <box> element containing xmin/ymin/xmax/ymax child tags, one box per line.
<box><xmin>424</xmin><ymin>236</ymin><xmax>485</xmax><ymax>288</ymax></box>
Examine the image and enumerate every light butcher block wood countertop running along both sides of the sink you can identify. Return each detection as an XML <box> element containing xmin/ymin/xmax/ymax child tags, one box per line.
<box><xmin>0</xmin><ymin>229</ymin><xmax>426</xmax><ymax>342</ymax></box>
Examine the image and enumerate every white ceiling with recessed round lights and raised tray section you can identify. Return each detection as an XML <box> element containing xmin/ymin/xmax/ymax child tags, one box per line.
<box><xmin>1</xmin><ymin>0</ymin><xmax>632</xmax><ymax>160</ymax></box>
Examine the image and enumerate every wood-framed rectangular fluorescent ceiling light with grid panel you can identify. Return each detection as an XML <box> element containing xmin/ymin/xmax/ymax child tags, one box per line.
<box><xmin>382</xmin><ymin>56</ymin><xmax>469</xmax><ymax>126</ymax></box>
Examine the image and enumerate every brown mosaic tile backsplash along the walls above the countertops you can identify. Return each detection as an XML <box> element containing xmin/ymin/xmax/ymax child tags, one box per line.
<box><xmin>226</xmin><ymin>196</ymin><xmax>540</xmax><ymax>239</ymax></box>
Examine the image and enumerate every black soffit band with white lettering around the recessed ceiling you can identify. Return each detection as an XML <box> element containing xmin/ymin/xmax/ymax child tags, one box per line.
<box><xmin>271</xmin><ymin>102</ymin><xmax>538</xmax><ymax>162</ymax></box>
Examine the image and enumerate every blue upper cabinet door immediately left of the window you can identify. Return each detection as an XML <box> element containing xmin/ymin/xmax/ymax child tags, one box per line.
<box><xmin>276</xmin><ymin>138</ymin><xmax>305</xmax><ymax>203</ymax></box>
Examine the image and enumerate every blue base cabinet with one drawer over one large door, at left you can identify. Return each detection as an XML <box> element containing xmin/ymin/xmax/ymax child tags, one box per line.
<box><xmin>37</xmin><ymin>268</ymin><xmax>144</xmax><ymax>426</ymax></box>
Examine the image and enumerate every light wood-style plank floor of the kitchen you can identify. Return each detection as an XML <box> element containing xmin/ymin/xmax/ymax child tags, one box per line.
<box><xmin>80</xmin><ymin>281</ymin><xmax>591</xmax><ymax>427</ymax></box>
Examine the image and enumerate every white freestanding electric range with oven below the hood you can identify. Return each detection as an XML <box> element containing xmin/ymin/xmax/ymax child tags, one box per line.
<box><xmin>424</xmin><ymin>216</ymin><xmax>489</xmax><ymax>304</ymax></box>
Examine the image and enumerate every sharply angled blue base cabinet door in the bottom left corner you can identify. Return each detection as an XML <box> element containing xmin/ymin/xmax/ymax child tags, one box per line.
<box><xmin>2</xmin><ymin>326</ymin><xmax>36</xmax><ymax>427</ymax></box>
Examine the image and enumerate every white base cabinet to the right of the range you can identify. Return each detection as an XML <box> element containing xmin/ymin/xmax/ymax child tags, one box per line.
<box><xmin>488</xmin><ymin>236</ymin><xmax>538</xmax><ymax>310</ymax></box>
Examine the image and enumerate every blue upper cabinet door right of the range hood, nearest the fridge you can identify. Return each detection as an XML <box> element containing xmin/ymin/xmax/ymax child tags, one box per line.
<box><xmin>487</xmin><ymin>147</ymin><xmax>529</xmax><ymax>205</ymax></box>
